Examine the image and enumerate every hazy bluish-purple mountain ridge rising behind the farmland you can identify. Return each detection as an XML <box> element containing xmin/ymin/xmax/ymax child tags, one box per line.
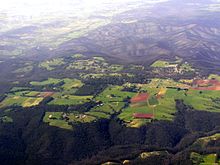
<box><xmin>56</xmin><ymin>11</ymin><xmax>220</xmax><ymax>69</ymax></box>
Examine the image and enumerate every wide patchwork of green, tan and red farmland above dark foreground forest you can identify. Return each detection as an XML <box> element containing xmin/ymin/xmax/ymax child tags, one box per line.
<box><xmin>0</xmin><ymin>74</ymin><xmax>220</xmax><ymax>129</ymax></box>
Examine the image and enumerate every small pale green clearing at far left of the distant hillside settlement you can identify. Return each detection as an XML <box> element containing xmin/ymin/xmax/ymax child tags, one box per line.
<box><xmin>39</xmin><ymin>58</ymin><xmax>65</xmax><ymax>71</ymax></box>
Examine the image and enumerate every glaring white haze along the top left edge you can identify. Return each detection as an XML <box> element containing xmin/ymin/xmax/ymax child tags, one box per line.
<box><xmin>0</xmin><ymin>0</ymin><xmax>167</xmax><ymax>16</ymax></box>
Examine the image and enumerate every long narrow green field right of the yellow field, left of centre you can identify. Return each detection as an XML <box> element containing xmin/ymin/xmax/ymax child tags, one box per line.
<box><xmin>49</xmin><ymin>93</ymin><xmax>93</xmax><ymax>105</ymax></box>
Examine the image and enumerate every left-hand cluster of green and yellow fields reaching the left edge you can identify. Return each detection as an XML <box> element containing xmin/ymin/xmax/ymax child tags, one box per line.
<box><xmin>0</xmin><ymin>78</ymin><xmax>84</xmax><ymax>107</ymax></box>
